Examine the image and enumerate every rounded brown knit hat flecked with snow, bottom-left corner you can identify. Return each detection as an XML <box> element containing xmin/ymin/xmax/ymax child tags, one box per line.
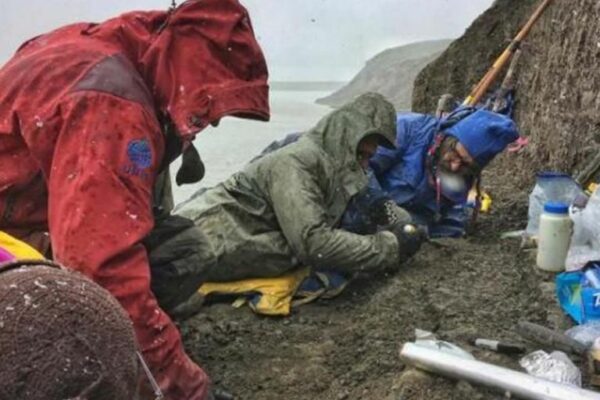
<box><xmin>0</xmin><ymin>264</ymin><xmax>143</xmax><ymax>400</ymax></box>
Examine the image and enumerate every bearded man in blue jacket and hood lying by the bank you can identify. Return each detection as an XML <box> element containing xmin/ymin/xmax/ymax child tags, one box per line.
<box><xmin>366</xmin><ymin>108</ymin><xmax>519</xmax><ymax>237</ymax></box>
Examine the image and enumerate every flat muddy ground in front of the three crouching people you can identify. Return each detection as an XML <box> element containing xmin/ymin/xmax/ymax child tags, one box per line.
<box><xmin>177</xmin><ymin>166</ymin><xmax>580</xmax><ymax>400</ymax></box>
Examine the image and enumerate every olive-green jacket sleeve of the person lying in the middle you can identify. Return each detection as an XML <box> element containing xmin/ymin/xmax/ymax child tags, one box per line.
<box><xmin>269</xmin><ymin>158</ymin><xmax>398</xmax><ymax>271</ymax></box>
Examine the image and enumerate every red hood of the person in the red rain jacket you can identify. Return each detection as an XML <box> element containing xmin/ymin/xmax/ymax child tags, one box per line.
<box><xmin>86</xmin><ymin>0</ymin><xmax>270</xmax><ymax>139</ymax></box>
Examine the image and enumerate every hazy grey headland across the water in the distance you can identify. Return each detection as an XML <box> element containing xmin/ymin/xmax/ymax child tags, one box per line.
<box><xmin>317</xmin><ymin>40</ymin><xmax>451</xmax><ymax>110</ymax></box>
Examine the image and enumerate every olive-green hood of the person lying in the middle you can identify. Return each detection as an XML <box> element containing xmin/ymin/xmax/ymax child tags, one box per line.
<box><xmin>307</xmin><ymin>93</ymin><xmax>396</xmax><ymax>169</ymax></box>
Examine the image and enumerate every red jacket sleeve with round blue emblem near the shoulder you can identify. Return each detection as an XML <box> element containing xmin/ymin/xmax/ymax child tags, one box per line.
<box><xmin>49</xmin><ymin>91</ymin><xmax>208</xmax><ymax>400</ymax></box>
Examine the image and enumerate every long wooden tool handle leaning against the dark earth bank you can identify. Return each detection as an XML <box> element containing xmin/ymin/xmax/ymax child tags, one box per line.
<box><xmin>463</xmin><ymin>0</ymin><xmax>552</xmax><ymax>106</ymax></box>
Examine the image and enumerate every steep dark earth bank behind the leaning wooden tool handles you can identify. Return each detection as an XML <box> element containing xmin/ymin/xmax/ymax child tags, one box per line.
<box><xmin>413</xmin><ymin>0</ymin><xmax>600</xmax><ymax>185</ymax></box>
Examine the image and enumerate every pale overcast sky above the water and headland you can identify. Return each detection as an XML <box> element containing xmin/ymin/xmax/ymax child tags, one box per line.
<box><xmin>0</xmin><ymin>0</ymin><xmax>493</xmax><ymax>81</ymax></box>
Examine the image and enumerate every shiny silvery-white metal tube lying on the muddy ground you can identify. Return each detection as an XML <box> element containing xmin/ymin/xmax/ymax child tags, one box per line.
<box><xmin>400</xmin><ymin>343</ymin><xmax>600</xmax><ymax>400</ymax></box>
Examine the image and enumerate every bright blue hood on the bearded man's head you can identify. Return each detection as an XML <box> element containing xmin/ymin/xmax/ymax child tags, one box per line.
<box><xmin>445</xmin><ymin>109</ymin><xmax>519</xmax><ymax>168</ymax></box>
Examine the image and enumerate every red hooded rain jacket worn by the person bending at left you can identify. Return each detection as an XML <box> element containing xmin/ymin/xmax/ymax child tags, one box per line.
<box><xmin>0</xmin><ymin>0</ymin><xmax>269</xmax><ymax>400</ymax></box>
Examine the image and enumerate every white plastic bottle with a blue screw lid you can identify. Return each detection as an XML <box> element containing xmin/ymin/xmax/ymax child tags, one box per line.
<box><xmin>537</xmin><ymin>202</ymin><xmax>573</xmax><ymax>272</ymax></box>
